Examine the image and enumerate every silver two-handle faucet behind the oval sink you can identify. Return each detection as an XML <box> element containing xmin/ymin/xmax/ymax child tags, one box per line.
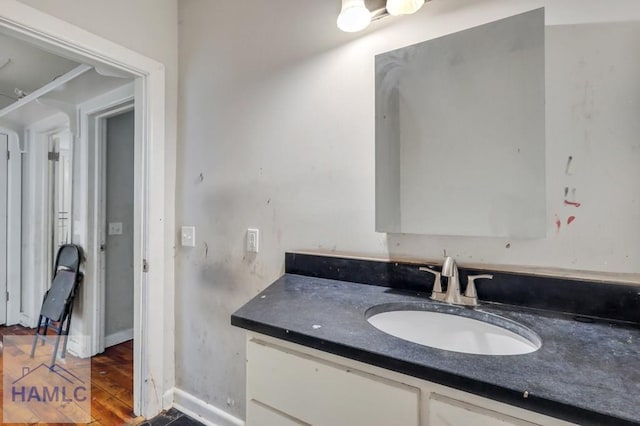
<box><xmin>420</xmin><ymin>256</ymin><xmax>493</xmax><ymax>306</ymax></box>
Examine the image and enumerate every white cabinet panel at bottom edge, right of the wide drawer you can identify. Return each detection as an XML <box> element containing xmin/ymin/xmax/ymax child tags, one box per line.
<box><xmin>429</xmin><ymin>393</ymin><xmax>537</xmax><ymax>426</ymax></box>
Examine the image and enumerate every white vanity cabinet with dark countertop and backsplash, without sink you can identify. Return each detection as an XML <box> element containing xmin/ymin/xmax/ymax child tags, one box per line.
<box><xmin>231</xmin><ymin>253</ymin><xmax>640</xmax><ymax>426</ymax></box>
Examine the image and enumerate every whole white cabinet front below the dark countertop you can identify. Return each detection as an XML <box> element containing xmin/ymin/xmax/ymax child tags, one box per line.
<box><xmin>247</xmin><ymin>335</ymin><xmax>577</xmax><ymax>426</ymax></box>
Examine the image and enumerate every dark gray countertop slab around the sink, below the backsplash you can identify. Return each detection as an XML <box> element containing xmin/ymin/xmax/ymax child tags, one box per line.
<box><xmin>231</xmin><ymin>274</ymin><xmax>640</xmax><ymax>425</ymax></box>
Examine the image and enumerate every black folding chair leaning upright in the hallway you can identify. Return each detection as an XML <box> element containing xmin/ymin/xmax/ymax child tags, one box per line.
<box><xmin>31</xmin><ymin>244</ymin><xmax>83</xmax><ymax>368</ymax></box>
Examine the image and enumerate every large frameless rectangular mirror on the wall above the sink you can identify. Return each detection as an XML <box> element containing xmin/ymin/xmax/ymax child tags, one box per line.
<box><xmin>375</xmin><ymin>9</ymin><xmax>546</xmax><ymax>238</ymax></box>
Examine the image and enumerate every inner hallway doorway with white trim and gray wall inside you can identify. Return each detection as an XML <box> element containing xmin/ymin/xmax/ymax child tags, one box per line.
<box><xmin>81</xmin><ymin>97</ymin><xmax>135</xmax><ymax>355</ymax></box>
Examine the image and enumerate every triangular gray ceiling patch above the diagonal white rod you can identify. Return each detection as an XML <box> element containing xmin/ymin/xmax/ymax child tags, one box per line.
<box><xmin>0</xmin><ymin>34</ymin><xmax>80</xmax><ymax>109</ymax></box>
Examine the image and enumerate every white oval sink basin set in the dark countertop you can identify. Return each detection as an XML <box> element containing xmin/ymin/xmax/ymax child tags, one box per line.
<box><xmin>368</xmin><ymin>310</ymin><xmax>541</xmax><ymax>355</ymax></box>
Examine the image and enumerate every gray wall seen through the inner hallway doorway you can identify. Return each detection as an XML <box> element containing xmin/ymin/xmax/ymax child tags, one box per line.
<box><xmin>105</xmin><ymin>111</ymin><xmax>134</xmax><ymax>336</ymax></box>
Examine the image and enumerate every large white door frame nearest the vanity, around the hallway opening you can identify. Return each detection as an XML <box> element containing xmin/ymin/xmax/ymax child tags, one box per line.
<box><xmin>0</xmin><ymin>0</ymin><xmax>175</xmax><ymax>418</ymax></box>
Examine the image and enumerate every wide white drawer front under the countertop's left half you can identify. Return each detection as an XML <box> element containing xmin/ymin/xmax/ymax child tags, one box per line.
<box><xmin>247</xmin><ymin>340</ymin><xmax>420</xmax><ymax>426</ymax></box>
